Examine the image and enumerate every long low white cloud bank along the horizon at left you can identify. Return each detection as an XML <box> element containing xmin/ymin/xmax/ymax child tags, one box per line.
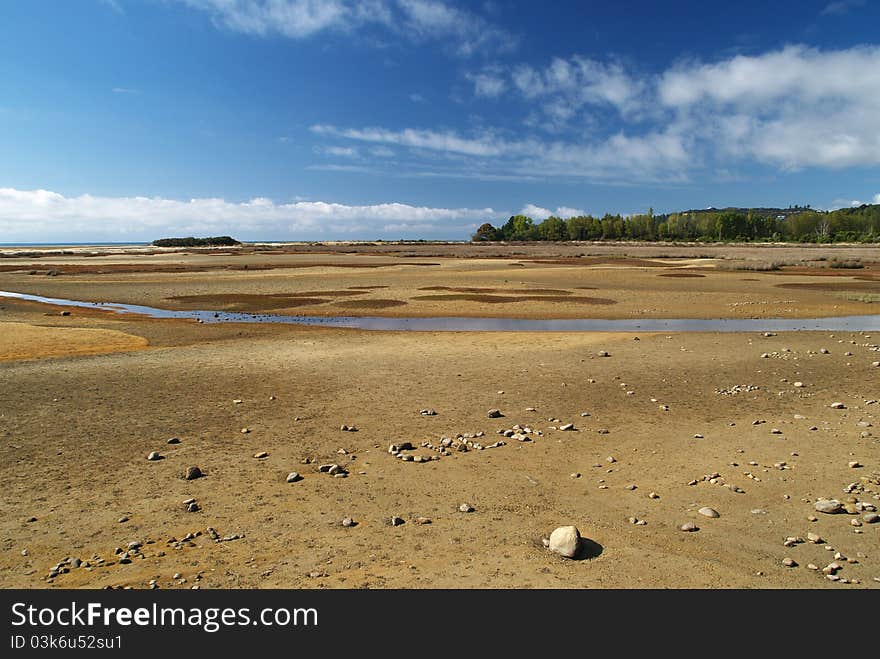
<box><xmin>0</xmin><ymin>188</ymin><xmax>504</xmax><ymax>242</ymax></box>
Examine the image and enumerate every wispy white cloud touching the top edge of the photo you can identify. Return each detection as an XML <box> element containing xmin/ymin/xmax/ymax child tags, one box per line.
<box><xmin>180</xmin><ymin>0</ymin><xmax>517</xmax><ymax>56</ymax></box>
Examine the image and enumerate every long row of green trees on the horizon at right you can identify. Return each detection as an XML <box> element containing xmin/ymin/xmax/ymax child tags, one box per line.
<box><xmin>471</xmin><ymin>204</ymin><xmax>880</xmax><ymax>243</ymax></box>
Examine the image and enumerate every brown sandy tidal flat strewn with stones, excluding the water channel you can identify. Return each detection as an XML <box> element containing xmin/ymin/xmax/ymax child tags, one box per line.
<box><xmin>0</xmin><ymin>245</ymin><xmax>880</xmax><ymax>588</ymax></box>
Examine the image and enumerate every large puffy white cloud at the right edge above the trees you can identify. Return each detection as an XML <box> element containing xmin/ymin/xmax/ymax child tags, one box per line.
<box><xmin>657</xmin><ymin>46</ymin><xmax>880</xmax><ymax>169</ymax></box>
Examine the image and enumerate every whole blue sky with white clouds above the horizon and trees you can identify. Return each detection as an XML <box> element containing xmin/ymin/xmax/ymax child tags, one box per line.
<box><xmin>0</xmin><ymin>0</ymin><xmax>880</xmax><ymax>242</ymax></box>
